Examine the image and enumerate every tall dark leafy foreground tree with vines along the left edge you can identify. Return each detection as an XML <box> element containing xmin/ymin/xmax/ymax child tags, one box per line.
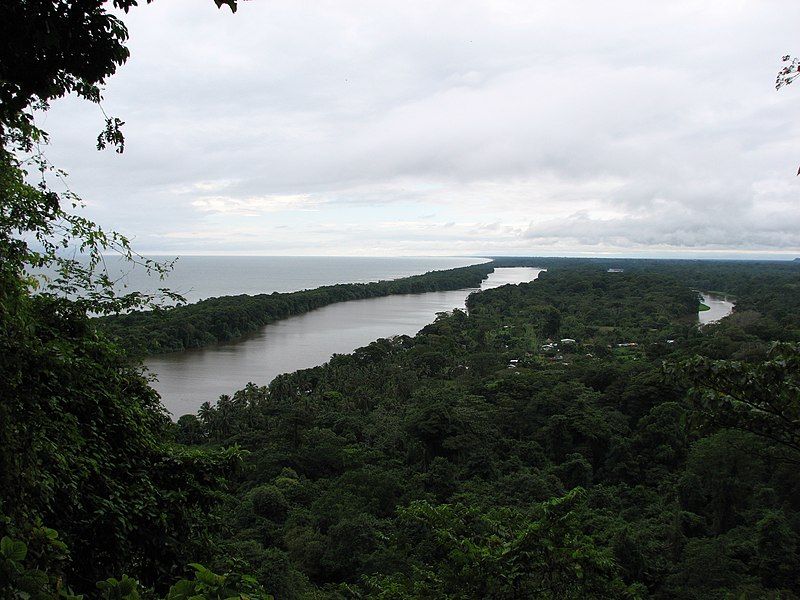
<box><xmin>0</xmin><ymin>0</ymin><xmax>247</xmax><ymax>589</ymax></box>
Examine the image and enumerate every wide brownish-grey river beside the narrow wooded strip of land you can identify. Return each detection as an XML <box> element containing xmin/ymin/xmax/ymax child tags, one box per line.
<box><xmin>145</xmin><ymin>267</ymin><xmax>541</xmax><ymax>416</ymax></box>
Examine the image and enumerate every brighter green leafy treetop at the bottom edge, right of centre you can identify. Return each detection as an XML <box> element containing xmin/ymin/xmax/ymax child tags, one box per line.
<box><xmin>366</xmin><ymin>488</ymin><xmax>640</xmax><ymax>600</ymax></box>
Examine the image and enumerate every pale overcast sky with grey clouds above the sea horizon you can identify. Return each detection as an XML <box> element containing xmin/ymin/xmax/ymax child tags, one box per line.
<box><xmin>39</xmin><ymin>0</ymin><xmax>800</xmax><ymax>258</ymax></box>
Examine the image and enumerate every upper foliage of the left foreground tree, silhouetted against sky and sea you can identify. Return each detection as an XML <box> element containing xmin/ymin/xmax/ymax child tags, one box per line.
<box><xmin>0</xmin><ymin>0</ymin><xmax>237</xmax><ymax>312</ymax></box>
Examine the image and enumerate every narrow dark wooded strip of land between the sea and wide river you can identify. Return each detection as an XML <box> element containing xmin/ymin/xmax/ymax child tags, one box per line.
<box><xmin>97</xmin><ymin>262</ymin><xmax>494</xmax><ymax>356</ymax></box>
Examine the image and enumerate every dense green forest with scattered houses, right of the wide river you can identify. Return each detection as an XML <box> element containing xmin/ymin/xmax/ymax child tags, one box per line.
<box><xmin>159</xmin><ymin>259</ymin><xmax>800</xmax><ymax>598</ymax></box>
